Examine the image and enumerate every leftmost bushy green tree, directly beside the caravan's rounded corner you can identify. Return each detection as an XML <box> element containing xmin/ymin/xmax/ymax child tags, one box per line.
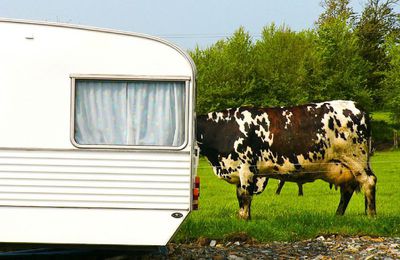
<box><xmin>190</xmin><ymin>27</ymin><xmax>255</xmax><ymax>113</ymax></box>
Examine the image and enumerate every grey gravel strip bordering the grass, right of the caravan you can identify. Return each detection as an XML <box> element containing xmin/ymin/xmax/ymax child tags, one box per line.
<box><xmin>165</xmin><ymin>235</ymin><xmax>400</xmax><ymax>260</ymax></box>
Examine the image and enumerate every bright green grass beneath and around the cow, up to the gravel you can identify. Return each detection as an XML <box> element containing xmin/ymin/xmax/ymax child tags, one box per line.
<box><xmin>174</xmin><ymin>151</ymin><xmax>400</xmax><ymax>242</ymax></box>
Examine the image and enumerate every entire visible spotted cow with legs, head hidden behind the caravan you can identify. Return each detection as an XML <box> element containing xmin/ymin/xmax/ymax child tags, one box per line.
<box><xmin>197</xmin><ymin>100</ymin><xmax>377</xmax><ymax>219</ymax></box>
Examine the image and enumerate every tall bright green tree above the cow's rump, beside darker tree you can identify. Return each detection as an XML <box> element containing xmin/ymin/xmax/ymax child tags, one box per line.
<box><xmin>316</xmin><ymin>0</ymin><xmax>372</xmax><ymax>108</ymax></box>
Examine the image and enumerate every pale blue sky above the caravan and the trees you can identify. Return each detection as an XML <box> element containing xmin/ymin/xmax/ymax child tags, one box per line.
<box><xmin>0</xmin><ymin>0</ymin><xmax>376</xmax><ymax>49</ymax></box>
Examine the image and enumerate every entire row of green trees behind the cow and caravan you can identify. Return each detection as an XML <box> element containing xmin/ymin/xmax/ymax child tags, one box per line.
<box><xmin>190</xmin><ymin>0</ymin><xmax>400</xmax><ymax>116</ymax></box>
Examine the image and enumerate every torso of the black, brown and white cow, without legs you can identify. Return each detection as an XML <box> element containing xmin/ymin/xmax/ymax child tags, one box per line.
<box><xmin>198</xmin><ymin>100</ymin><xmax>369</xmax><ymax>184</ymax></box>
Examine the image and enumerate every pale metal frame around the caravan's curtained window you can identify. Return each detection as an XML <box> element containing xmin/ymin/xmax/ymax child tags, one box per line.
<box><xmin>70</xmin><ymin>74</ymin><xmax>191</xmax><ymax>151</ymax></box>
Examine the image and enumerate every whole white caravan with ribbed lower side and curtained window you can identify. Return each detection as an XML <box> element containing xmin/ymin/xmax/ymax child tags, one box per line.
<box><xmin>0</xmin><ymin>19</ymin><xmax>197</xmax><ymax>246</ymax></box>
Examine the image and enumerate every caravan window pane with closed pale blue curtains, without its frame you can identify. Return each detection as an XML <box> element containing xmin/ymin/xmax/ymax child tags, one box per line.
<box><xmin>74</xmin><ymin>79</ymin><xmax>186</xmax><ymax>147</ymax></box>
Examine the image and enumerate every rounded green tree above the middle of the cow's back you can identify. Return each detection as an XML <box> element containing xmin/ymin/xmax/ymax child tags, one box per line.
<box><xmin>253</xmin><ymin>24</ymin><xmax>315</xmax><ymax>106</ymax></box>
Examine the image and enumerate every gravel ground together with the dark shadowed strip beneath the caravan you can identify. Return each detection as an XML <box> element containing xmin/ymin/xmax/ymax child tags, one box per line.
<box><xmin>0</xmin><ymin>234</ymin><xmax>400</xmax><ymax>260</ymax></box>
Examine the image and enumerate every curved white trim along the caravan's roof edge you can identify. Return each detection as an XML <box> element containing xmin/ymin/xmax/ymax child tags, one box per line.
<box><xmin>0</xmin><ymin>17</ymin><xmax>197</xmax><ymax>76</ymax></box>
